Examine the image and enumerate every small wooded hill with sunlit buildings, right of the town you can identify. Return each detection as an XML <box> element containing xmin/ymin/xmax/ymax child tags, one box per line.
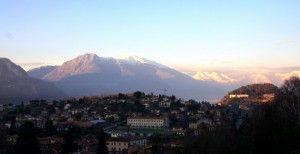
<box><xmin>219</xmin><ymin>83</ymin><xmax>279</xmax><ymax>104</ymax></box>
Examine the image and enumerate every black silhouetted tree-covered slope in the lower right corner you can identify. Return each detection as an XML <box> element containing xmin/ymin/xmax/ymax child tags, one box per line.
<box><xmin>166</xmin><ymin>77</ymin><xmax>300</xmax><ymax>154</ymax></box>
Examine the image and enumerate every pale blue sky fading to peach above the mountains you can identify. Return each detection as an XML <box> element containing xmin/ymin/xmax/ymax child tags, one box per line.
<box><xmin>0</xmin><ymin>0</ymin><xmax>300</xmax><ymax>67</ymax></box>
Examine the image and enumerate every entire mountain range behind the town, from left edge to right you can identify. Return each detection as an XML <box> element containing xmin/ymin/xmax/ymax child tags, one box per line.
<box><xmin>4</xmin><ymin>54</ymin><xmax>300</xmax><ymax>102</ymax></box>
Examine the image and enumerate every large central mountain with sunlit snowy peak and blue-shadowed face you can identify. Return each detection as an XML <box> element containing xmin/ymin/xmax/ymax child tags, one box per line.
<box><xmin>29</xmin><ymin>54</ymin><xmax>225</xmax><ymax>100</ymax></box>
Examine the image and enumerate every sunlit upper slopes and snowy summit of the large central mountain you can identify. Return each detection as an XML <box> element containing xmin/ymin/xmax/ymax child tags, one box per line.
<box><xmin>42</xmin><ymin>54</ymin><xmax>175</xmax><ymax>81</ymax></box>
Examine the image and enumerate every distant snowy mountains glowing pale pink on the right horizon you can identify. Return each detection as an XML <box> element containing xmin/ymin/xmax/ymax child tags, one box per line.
<box><xmin>174</xmin><ymin>66</ymin><xmax>300</xmax><ymax>88</ymax></box>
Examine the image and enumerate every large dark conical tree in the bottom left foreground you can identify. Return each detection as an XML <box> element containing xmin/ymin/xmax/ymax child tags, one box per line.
<box><xmin>14</xmin><ymin>122</ymin><xmax>40</xmax><ymax>154</ymax></box>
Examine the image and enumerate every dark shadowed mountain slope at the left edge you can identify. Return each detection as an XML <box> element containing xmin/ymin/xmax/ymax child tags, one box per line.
<box><xmin>0</xmin><ymin>58</ymin><xmax>65</xmax><ymax>104</ymax></box>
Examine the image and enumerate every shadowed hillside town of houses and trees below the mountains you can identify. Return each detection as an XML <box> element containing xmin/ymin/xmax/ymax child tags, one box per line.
<box><xmin>0</xmin><ymin>88</ymin><xmax>274</xmax><ymax>154</ymax></box>
